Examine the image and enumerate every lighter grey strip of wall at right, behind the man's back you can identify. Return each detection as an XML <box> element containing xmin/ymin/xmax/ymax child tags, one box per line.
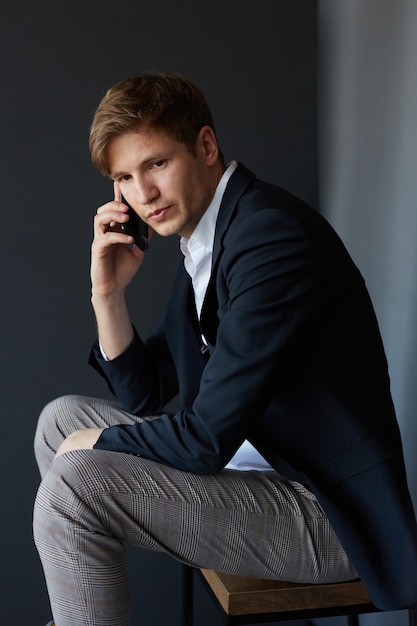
<box><xmin>319</xmin><ymin>0</ymin><xmax>417</xmax><ymax>516</ymax></box>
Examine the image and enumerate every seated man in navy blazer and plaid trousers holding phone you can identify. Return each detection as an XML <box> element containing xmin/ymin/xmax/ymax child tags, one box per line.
<box><xmin>34</xmin><ymin>73</ymin><xmax>417</xmax><ymax>626</ymax></box>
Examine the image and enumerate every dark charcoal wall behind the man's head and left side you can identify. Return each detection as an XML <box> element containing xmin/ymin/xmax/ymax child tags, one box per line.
<box><xmin>0</xmin><ymin>0</ymin><xmax>317</xmax><ymax>626</ymax></box>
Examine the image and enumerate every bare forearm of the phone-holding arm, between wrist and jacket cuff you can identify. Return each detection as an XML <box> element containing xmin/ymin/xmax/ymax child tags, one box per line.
<box><xmin>91</xmin><ymin>290</ymin><xmax>134</xmax><ymax>360</ymax></box>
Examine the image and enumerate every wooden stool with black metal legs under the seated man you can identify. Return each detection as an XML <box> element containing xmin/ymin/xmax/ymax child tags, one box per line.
<box><xmin>183</xmin><ymin>565</ymin><xmax>417</xmax><ymax>626</ymax></box>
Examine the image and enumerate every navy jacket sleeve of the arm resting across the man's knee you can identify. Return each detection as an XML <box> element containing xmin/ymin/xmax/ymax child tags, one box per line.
<box><xmin>95</xmin><ymin>209</ymin><xmax>325</xmax><ymax>474</ymax></box>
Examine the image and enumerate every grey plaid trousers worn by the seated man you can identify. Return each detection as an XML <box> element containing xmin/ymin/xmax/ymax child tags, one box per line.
<box><xmin>34</xmin><ymin>396</ymin><xmax>356</xmax><ymax>626</ymax></box>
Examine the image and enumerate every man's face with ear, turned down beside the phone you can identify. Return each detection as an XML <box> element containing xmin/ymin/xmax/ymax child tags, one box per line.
<box><xmin>107</xmin><ymin>127</ymin><xmax>223</xmax><ymax>238</ymax></box>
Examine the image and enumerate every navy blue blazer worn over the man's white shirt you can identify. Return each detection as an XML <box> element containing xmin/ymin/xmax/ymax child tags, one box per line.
<box><xmin>90</xmin><ymin>165</ymin><xmax>417</xmax><ymax>609</ymax></box>
